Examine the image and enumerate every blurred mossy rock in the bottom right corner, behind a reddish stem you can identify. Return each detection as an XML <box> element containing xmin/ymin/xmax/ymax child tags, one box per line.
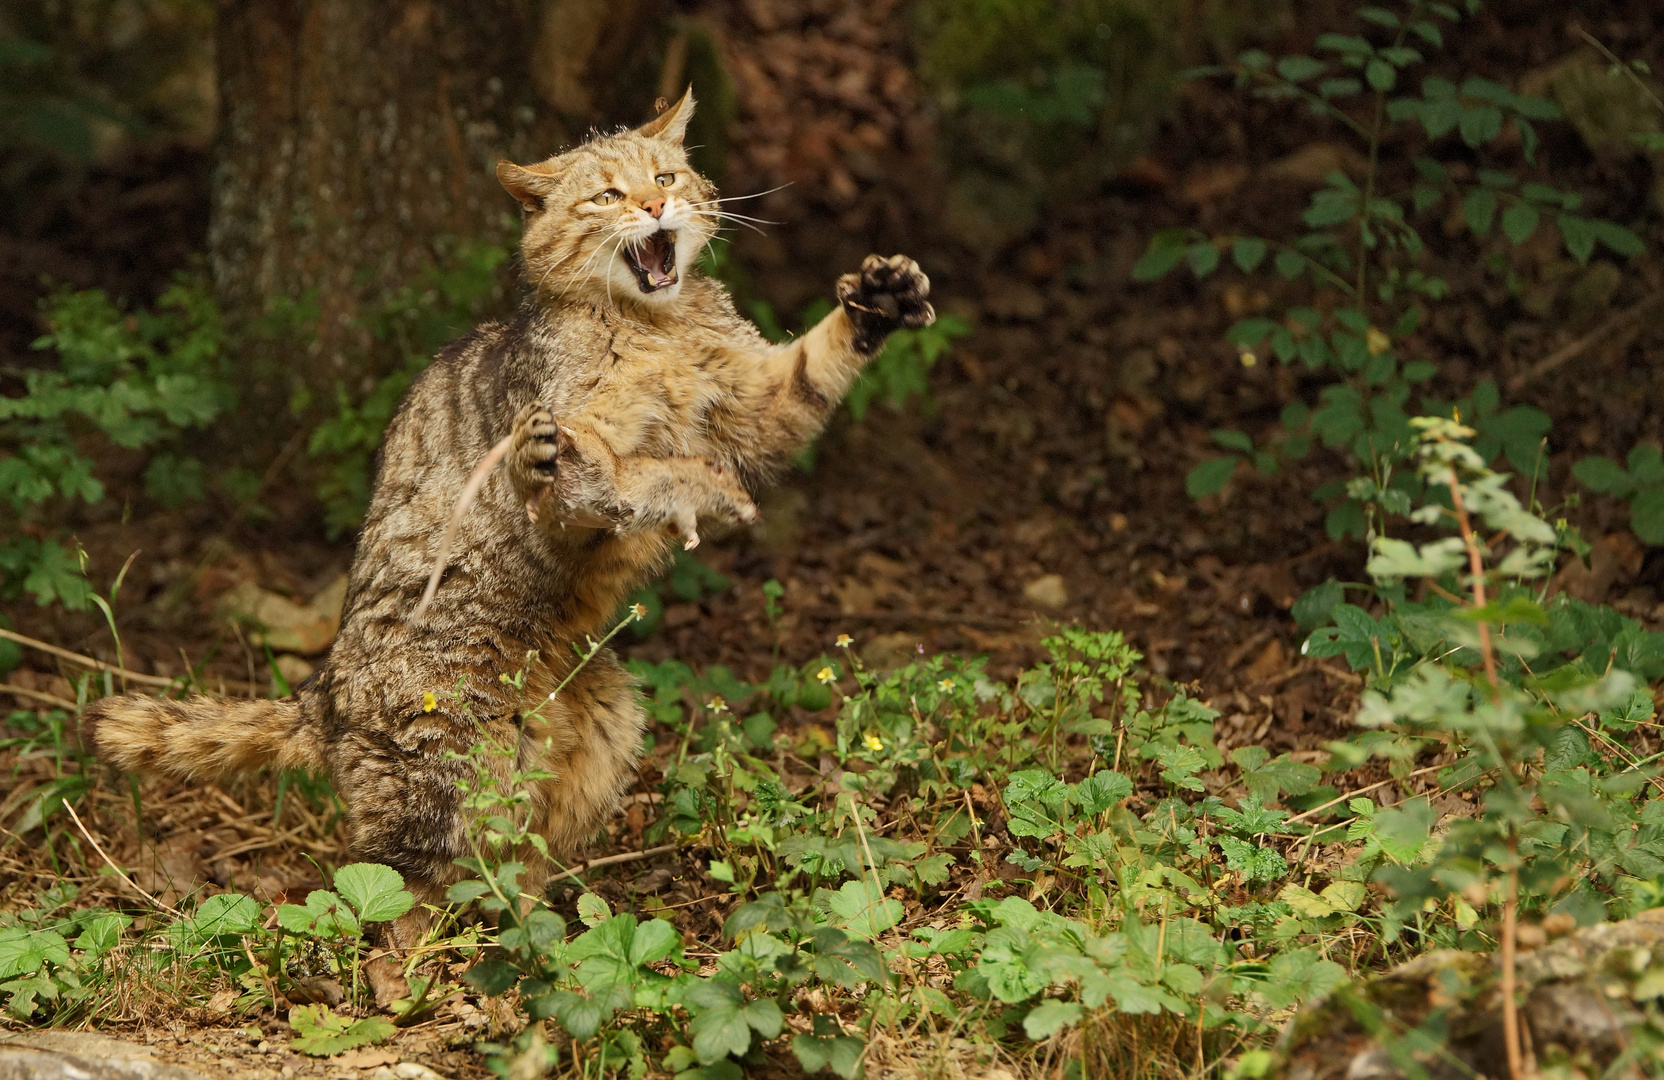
<box><xmin>1273</xmin><ymin>909</ymin><xmax>1664</xmax><ymax>1080</ymax></box>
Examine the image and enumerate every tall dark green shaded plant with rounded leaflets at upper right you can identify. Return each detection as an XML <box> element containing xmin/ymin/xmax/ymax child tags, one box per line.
<box><xmin>1133</xmin><ymin>0</ymin><xmax>1642</xmax><ymax>539</ymax></box>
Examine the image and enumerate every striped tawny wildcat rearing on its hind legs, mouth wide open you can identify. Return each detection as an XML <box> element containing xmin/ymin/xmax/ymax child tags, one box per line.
<box><xmin>82</xmin><ymin>93</ymin><xmax>934</xmax><ymax>939</ymax></box>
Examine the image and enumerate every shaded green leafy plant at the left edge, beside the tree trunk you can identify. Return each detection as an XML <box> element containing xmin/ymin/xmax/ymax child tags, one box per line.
<box><xmin>0</xmin><ymin>278</ymin><xmax>236</xmax><ymax>611</ymax></box>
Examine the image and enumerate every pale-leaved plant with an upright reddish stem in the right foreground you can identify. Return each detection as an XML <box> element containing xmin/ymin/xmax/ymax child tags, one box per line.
<box><xmin>1303</xmin><ymin>418</ymin><xmax>1664</xmax><ymax>1062</ymax></box>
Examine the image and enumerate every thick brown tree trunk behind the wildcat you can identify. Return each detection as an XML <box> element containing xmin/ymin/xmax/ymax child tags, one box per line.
<box><xmin>210</xmin><ymin>0</ymin><xmax>567</xmax><ymax>412</ymax></box>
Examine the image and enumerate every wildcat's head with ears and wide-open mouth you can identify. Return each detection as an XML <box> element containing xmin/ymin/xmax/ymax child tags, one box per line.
<box><xmin>498</xmin><ymin>90</ymin><xmax>717</xmax><ymax>308</ymax></box>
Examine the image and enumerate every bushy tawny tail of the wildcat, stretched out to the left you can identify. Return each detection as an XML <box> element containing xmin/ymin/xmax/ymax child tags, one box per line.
<box><xmin>82</xmin><ymin>694</ymin><xmax>324</xmax><ymax>780</ymax></box>
